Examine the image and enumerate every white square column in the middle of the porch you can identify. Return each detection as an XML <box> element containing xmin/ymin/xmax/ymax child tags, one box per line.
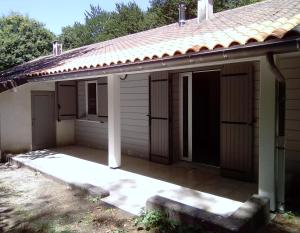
<box><xmin>107</xmin><ymin>75</ymin><xmax>121</xmax><ymax>168</ymax></box>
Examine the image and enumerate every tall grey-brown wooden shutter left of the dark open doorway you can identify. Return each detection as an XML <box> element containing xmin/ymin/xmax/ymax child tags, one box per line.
<box><xmin>149</xmin><ymin>72</ymin><xmax>171</xmax><ymax>164</ymax></box>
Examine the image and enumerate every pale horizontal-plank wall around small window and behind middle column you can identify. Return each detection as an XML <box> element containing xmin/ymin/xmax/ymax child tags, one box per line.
<box><xmin>75</xmin><ymin>74</ymin><xmax>149</xmax><ymax>158</ymax></box>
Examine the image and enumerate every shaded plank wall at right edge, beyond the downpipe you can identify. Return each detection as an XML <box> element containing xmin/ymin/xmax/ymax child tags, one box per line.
<box><xmin>278</xmin><ymin>53</ymin><xmax>300</xmax><ymax>179</ymax></box>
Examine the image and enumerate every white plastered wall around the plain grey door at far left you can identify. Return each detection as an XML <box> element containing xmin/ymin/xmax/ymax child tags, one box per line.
<box><xmin>0</xmin><ymin>83</ymin><xmax>73</xmax><ymax>153</ymax></box>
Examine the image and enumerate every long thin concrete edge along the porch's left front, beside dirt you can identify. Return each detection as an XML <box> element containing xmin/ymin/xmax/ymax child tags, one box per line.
<box><xmin>9</xmin><ymin>157</ymin><xmax>110</xmax><ymax>198</ymax></box>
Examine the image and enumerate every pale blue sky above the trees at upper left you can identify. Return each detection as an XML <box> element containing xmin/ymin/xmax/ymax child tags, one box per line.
<box><xmin>0</xmin><ymin>0</ymin><xmax>149</xmax><ymax>34</ymax></box>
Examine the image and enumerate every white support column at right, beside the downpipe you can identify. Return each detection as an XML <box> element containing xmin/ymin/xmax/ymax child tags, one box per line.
<box><xmin>258</xmin><ymin>57</ymin><xmax>276</xmax><ymax>210</ymax></box>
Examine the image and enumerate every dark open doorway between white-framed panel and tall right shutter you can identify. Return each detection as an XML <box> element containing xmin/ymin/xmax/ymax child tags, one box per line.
<box><xmin>192</xmin><ymin>71</ymin><xmax>220</xmax><ymax>166</ymax></box>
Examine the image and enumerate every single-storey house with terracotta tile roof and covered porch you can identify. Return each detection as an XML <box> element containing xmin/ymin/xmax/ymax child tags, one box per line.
<box><xmin>0</xmin><ymin>0</ymin><xmax>300</xmax><ymax>213</ymax></box>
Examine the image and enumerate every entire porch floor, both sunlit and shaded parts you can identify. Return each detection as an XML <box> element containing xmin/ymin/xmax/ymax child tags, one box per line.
<box><xmin>13</xmin><ymin>146</ymin><xmax>257</xmax><ymax>216</ymax></box>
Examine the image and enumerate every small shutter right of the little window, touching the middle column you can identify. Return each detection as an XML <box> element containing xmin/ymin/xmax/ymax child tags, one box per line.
<box><xmin>98</xmin><ymin>77</ymin><xmax>108</xmax><ymax>118</ymax></box>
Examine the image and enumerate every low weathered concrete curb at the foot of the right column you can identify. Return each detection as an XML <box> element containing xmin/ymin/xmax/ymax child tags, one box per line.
<box><xmin>146</xmin><ymin>195</ymin><xmax>270</xmax><ymax>233</ymax></box>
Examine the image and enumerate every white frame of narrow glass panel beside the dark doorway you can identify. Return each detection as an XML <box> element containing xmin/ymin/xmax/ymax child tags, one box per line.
<box><xmin>179</xmin><ymin>72</ymin><xmax>193</xmax><ymax>161</ymax></box>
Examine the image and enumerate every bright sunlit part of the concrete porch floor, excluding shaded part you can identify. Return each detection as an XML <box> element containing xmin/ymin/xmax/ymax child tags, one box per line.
<box><xmin>12</xmin><ymin>147</ymin><xmax>248</xmax><ymax>217</ymax></box>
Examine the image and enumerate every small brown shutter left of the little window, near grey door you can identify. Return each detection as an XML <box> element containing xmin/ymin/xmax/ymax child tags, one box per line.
<box><xmin>56</xmin><ymin>81</ymin><xmax>77</xmax><ymax>121</ymax></box>
